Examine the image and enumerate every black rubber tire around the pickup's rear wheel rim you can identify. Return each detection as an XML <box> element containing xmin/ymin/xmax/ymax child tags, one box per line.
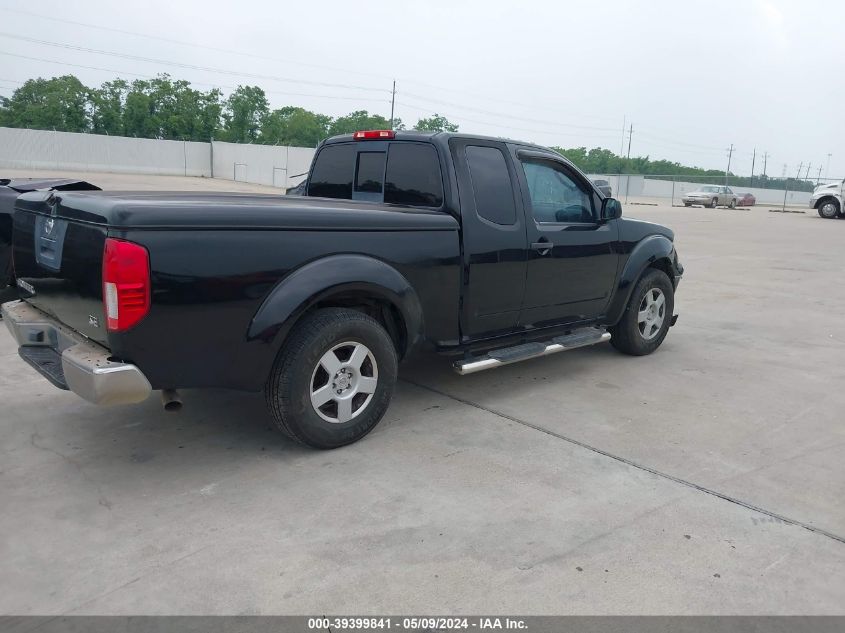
<box><xmin>265</xmin><ymin>308</ymin><xmax>398</xmax><ymax>449</ymax></box>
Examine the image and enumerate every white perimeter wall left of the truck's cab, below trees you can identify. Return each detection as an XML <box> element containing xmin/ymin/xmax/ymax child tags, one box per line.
<box><xmin>0</xmin><ymin>127</ymin><xmax>314</xmax><ymax>188</ymax></box>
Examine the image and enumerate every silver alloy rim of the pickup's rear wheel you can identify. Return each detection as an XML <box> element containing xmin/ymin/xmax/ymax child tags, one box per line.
<box><xmin>309</xmin><ymin>341</ymin><xmax>378</xmax><ymax>424</ymax></box>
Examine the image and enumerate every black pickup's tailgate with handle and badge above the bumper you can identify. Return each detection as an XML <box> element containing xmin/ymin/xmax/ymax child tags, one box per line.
<box><xmin>13</xmin><ymin>192</ymin><xmax>108</xmax><ymax>347</ymax></box>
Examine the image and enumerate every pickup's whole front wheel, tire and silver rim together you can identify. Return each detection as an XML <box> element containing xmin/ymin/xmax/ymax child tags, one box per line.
<box><xmin>610</xmin><ymin>269</ymin><xmax>675</xmax><ymax>356</ymax></box>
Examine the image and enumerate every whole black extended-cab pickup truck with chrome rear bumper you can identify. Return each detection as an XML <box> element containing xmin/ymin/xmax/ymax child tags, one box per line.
<box><xmin>2</xmin><ymin>131</ymin><xmax>683</xmax><ymax>448</ymax></box>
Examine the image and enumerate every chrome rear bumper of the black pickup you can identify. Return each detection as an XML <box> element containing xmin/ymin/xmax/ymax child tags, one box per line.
<box><xmin>2</xmin><ymin>301</ymin><xmax>152</xmax><ymax>404</ymax></box>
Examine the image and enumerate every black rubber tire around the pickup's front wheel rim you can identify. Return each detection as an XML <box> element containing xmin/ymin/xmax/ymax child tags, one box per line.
<box><xmin>609</xmin><ymin>268</ymin><xmax>675</xmax><ymax>356</ymax></box>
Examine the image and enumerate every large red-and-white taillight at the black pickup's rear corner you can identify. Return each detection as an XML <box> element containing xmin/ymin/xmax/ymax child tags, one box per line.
<box><xmin>103</xmin><ymin>238</ymin><xmax>150</xmax><ymax>332</ymax></box>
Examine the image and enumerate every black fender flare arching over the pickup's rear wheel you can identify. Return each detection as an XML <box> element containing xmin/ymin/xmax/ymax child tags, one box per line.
<box><xmin>247</xmin><ymin>254</ymin><xmax>423</xmax><ymax>357</ymax></box>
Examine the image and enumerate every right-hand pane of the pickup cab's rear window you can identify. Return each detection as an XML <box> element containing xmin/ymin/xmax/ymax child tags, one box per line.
<box><xmin>384</xmin><ymin>143</ymin><xmax>443</xmax><ymax>207</ymax></box>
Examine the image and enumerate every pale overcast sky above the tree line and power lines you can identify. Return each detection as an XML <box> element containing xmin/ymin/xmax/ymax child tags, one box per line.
<box><xmin>0</xmin><ymin>0</ymin><xmax>845</xmax><ymax>177</ymax></box>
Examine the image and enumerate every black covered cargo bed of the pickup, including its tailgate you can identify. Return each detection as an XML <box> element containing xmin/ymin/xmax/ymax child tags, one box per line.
<box><xmin>9</xmin><ymin>192</ymin><xmax>460</xmax><ymax>389</ymax></box>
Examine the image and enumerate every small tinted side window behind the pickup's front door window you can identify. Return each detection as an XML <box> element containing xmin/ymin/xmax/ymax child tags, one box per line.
<box><xmin>466</xmin><ymin>145</ymin><xmax>516</xmax><ymax>225</ymax></box>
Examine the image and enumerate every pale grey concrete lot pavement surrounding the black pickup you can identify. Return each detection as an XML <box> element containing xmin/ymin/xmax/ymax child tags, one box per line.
<box><xmin>0</xmin><ymin>174</ymin><xmax>845</xmax><ymax>614</ymax></box>
